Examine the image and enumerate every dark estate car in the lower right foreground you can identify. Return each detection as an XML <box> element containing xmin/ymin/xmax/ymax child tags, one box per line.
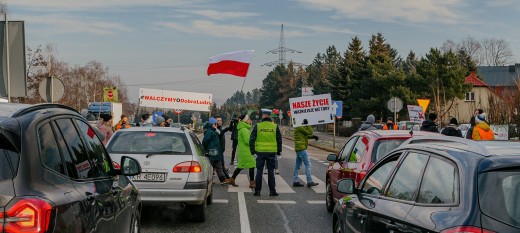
<box><xmin>333</xmin><ymin>136</ymin><xmax>520</xmax><ymax>233</ymax></box>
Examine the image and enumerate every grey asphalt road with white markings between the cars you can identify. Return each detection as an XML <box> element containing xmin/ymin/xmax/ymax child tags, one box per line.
<box><xmin>141</xmin><ymin>134</ymin><xmax>332</xmax><ymax>233</ymax></box>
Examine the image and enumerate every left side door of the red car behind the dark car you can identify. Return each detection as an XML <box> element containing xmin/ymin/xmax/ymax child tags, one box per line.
<box><xmin>329</xmin><ymin>136</ymin><xmax>358</xmax><ymax>199</ymax></box>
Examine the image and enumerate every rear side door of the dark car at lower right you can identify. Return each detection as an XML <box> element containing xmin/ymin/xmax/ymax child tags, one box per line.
<box><xmin>362</xmin><ymin>152</ymin><xmax>429</xmax><ymax>232</ymax></box>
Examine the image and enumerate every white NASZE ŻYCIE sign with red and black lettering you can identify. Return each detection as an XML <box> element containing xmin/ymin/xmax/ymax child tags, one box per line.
<box><xmin>289</xmin><ymin>94</ymin><xmax>334</xmax><ymax>127</ymax></box>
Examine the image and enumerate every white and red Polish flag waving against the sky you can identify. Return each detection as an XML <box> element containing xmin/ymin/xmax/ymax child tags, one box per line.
<box><xmin>208</xmin><ymin>50</ymin><xmax>254</xmax><ymax>77</ymax></box>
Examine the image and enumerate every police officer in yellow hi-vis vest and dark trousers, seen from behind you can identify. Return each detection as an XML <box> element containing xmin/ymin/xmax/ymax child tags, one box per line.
<box><xmin>249</xmin><ymin>109</ymin><xmax>282</xmax><ymax>196</ymax></box>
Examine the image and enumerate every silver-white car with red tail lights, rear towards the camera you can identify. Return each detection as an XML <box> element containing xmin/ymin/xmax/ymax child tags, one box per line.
<box><xmin>107</xmin><ymin>127</ymin><xmax>213</xmax><ymax>222</ymax></box>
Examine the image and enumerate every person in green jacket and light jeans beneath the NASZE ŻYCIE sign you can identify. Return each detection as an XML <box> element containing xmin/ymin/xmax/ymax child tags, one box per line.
<box><xmin>293</xmin><ymin>119</ymin><xmax>318</xmax><ymax>187</ymax></box>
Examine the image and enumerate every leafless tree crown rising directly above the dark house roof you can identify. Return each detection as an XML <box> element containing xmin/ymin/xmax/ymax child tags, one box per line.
<box><xmin>482</xmin><ymin>38</ymin><xmax>513</xmax><ymax>66</ymax></box>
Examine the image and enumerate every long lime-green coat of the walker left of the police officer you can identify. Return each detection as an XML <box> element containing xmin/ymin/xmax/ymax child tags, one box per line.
<box><xmin>237</xmin><ymin>121</ymin><xmax>256</xmax><ymax>169</ymax></box>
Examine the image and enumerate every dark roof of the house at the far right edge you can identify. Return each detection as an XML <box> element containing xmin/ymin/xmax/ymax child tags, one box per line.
<box><xmin>477</xmin><ymin>64</ymin><xmax>520</xmax><ymax>87</ymax></box>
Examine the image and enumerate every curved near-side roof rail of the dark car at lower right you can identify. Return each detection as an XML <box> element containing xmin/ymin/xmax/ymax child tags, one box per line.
<box><xmin>401</xmin><ymin>135</ymin><xmax>491</xmax><ymax>156</ymax></box>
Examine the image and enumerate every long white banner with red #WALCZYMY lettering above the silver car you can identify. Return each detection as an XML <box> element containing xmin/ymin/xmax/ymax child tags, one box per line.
<box><xmin>139</xmin><ymin>88</ymin><xmax>212</xmax><ymax>112</ymax></box>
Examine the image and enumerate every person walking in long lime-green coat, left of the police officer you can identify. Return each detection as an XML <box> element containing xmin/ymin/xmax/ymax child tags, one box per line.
<box><xmin>229</xmin><ymin>115</ymin><xmax>256</xmax><ymax>188</ymax></box>
